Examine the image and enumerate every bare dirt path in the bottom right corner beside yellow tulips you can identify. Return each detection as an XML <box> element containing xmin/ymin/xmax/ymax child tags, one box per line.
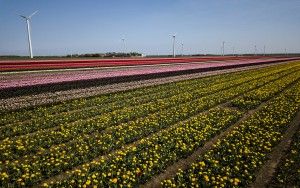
<box><xmin>250</xmin><ymin>111</ymin><xmax>300</xmax><ymax>188</ymax></box>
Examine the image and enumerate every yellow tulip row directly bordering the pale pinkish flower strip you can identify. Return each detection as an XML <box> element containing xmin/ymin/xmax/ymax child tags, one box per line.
<box><xmin>0</xmin><ymin>60</ymin><xmax>297</xmax><ymax>126</ymax></box>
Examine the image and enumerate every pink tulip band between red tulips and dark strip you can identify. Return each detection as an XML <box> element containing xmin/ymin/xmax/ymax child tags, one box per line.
<box><xmin>0</xmin><ymin>58</ymin><xmax>294</xmax><ymax>91</ymax></box>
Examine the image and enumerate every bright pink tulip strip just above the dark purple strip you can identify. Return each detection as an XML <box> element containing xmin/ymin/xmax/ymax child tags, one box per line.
<box><xmin>0</xmin><ymin>58</ymin><xmax>293</xmax><ymax>90</ymax></box>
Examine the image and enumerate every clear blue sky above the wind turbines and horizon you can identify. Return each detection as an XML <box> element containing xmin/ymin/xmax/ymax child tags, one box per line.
<box><xmin>0</xmin><ymin>0</ymin><xmax>300</xmax><ymax>55</ymax></box>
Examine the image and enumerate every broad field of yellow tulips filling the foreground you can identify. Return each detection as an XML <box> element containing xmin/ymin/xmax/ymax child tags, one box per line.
<box><xmin>0</xmin><ymin>60</ymin><xmax>300</xmax><ymax>188</ymax></box>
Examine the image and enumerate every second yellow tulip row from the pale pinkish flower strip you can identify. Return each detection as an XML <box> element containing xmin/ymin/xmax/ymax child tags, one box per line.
<box><xmin>0</xmin><ymin>61</ymin><xmax>276</xmax><ymax>139</ymax></box>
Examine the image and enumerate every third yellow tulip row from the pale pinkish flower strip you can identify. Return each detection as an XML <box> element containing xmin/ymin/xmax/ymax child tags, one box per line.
<box><xmin>0</xmin><ymin>61</ymin><xmax>290</xmax><ymax>160</ymax></box>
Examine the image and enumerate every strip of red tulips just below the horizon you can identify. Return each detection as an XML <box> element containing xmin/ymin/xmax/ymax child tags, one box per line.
<box><xmin>0</xmin><ymin>56</ymin><xmax>264</xmax><ymax>71</ymax></box>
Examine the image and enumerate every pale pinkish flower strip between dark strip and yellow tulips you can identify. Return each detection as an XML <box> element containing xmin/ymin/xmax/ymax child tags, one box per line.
<box><xmin>0</xmin><ymin>61</ymin><xmax>291</xmax><ymax>111</ymax></box>
